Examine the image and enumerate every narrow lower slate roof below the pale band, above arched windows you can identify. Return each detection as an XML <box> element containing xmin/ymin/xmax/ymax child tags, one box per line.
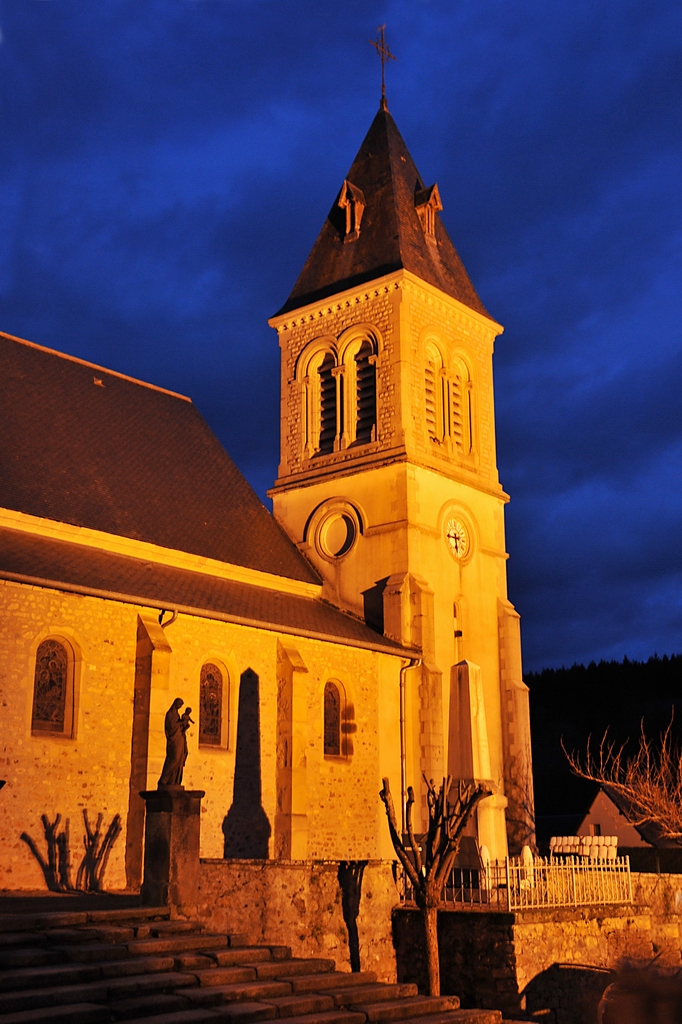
<box><xmin>0</xmin><ymin>528</ymin><xmax>406</xmax><ymax>655</ymax></box>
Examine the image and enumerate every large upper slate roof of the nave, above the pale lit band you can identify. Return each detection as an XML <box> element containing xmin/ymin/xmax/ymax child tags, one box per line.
<box><xmin>0</xmin><ymin>334</ymin><xmax>319</xmax><ymax>584</ymax></box>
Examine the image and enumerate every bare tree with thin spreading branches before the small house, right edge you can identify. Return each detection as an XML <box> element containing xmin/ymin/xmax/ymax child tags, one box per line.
<box><xmin>563</xmin><ymin>719</ymin><xmax>682</xmax><ymax>846</ymax></box>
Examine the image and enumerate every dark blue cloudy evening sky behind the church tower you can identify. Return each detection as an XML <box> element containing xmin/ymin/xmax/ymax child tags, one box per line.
<box><xmin>0</xmin><ymin>0</ymin><xmax>682</xmax><ymax>669</ymax></box>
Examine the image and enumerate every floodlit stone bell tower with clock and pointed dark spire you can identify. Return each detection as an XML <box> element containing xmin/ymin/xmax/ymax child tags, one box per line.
<box><xmin>269</xmin><ymin>101</ymin><xmax>532</xmax><ymax>858</ymax></box>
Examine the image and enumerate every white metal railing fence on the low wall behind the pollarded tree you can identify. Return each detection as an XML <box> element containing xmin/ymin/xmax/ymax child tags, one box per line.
<box><xmin>400</xmin><ymin>857</ymin><xmax>632</xmax><ymax>910</ymax></box>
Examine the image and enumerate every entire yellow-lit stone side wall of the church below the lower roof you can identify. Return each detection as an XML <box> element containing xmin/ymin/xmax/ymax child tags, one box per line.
<box><xmin>0</xmin><ymin>581</ymin><xmax>400</xmax><ymax>890</ymax></box>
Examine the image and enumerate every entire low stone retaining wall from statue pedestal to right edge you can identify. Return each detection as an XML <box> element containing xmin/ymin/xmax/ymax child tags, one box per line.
<box><xmin>199</xmin><ymin>859</ymin><xmax>682</xmax><ymax>1024</ymax></box>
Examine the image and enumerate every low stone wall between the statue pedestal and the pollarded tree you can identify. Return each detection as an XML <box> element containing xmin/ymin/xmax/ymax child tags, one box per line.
<box><xmin>199</xmin><ymin>859</ymin><xmax>398</xmax><ymax>982</ymax></box>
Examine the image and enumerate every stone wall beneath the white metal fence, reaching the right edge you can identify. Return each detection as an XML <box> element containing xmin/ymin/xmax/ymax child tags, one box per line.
<box><xmin>393</xmin><ymin>873</ymin><xmax>682</xmax><ymax>1024</ymax></box>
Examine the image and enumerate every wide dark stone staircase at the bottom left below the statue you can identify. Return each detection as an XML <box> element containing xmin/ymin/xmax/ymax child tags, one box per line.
<box><xmin>0</xmin><ymin>907</ymin><xmax>502</xmax><ymax>1024</ymax></box>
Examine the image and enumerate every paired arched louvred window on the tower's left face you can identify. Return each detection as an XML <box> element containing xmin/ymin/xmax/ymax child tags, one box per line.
<box><xmin>297</xmin><ymin>336</ymin><xmax>377</xmax><ymax>458</ymax></box>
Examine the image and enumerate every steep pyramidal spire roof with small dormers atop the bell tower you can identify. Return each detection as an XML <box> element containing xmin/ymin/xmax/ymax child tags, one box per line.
<box><xmin>278</xmin><ymin>108</ymin><xmax>488</xmax><ymax>316</ymax></box>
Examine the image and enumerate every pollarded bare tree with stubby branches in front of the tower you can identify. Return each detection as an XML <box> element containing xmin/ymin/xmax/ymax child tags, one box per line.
<box><xmin>379</xmin><ymin>775</ymin><xmax>491</xmax><ymax>995</ymax></box>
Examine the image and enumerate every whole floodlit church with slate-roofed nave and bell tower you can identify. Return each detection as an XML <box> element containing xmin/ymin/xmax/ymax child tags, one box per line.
<box><xmin>0</xmin><ymin>100</ymin><xmax>534</xmax><ymax>890</ymax></box>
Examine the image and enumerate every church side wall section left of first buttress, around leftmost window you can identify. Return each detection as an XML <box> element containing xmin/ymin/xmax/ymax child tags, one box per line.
<box><xmin>0</xmin><ymin>581</ymin><xmax>137</xmax><ymax>890</ymax></box>
